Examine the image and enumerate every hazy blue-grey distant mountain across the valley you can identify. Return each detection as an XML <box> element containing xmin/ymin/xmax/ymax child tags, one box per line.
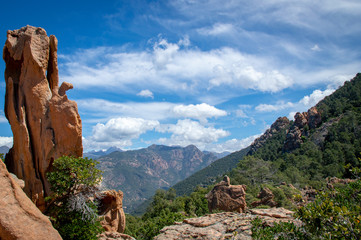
<box><xmin>98</xmin><ymin>145</ymin><xmax>217</xmax><ymax>212</ymax></box>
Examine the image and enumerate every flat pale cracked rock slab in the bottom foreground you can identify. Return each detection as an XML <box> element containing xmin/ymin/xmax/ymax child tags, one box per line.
<box><xmin>154</xmin><ymin>208</ymin><xmax>300</xmax><ymax>240</ymax></box>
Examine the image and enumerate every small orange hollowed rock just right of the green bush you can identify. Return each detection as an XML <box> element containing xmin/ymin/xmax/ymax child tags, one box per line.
<box><xmin>99</xmin><ymin>190</ymin><xmax>125</xmax><ymax>233</ymax></box>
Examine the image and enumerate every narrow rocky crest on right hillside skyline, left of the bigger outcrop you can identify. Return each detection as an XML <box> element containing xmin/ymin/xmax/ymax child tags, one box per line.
<box><xmin>249</xmin><ymin>117</ymin><xmax>290</xmax><ymax>154</ymax></box>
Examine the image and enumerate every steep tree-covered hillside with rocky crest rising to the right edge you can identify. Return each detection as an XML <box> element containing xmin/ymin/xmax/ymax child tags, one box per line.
<box><xmin>231</xmin><ymin>74</ymin><xmax>361</xmax><ymax>188</ymax></box>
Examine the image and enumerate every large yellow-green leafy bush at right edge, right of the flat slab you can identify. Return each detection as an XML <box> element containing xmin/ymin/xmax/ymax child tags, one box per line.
<box><xmin>296</xmin><ymin>176</ymin><xmax>361</xmax><ymax>239</ymax></box>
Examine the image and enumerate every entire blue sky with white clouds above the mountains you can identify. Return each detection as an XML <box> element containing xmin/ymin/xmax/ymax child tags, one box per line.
<box><xmin>0</xmin><ymin>0</ymin><xmax>361</xmax><ymax>152</ymax></box>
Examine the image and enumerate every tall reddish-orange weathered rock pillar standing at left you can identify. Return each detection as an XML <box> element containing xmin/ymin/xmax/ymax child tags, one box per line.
<box><xmin>3</xmin><ymin>26</ymin><xmax>83</xmax><ymax>209</ymax></box>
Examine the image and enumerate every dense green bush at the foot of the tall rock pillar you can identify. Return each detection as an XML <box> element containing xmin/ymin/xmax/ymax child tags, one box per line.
<box><xmin>47</xmin><ymin>156</ymin><xmax>103</xmax><ymax>240</ymax></box>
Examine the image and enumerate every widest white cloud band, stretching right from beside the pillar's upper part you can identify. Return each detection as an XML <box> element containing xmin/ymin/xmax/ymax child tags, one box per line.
<box><xmin>61</xmin><ymin>38</ymin><xmax>293</xmax><ymax>96</ymax></box>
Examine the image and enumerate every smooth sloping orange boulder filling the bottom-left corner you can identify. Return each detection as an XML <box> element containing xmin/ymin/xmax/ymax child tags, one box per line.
<box><xmin>0</xmin><ymin>160</ymin><xmax>61</xmax><ymax>240</ymax></box>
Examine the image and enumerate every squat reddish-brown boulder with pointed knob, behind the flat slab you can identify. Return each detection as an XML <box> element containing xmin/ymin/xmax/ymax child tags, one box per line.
<box><xmin>206</xmin><ymin>176</ymin><xmax>247</xmax><ymax>213</ymax></box>
